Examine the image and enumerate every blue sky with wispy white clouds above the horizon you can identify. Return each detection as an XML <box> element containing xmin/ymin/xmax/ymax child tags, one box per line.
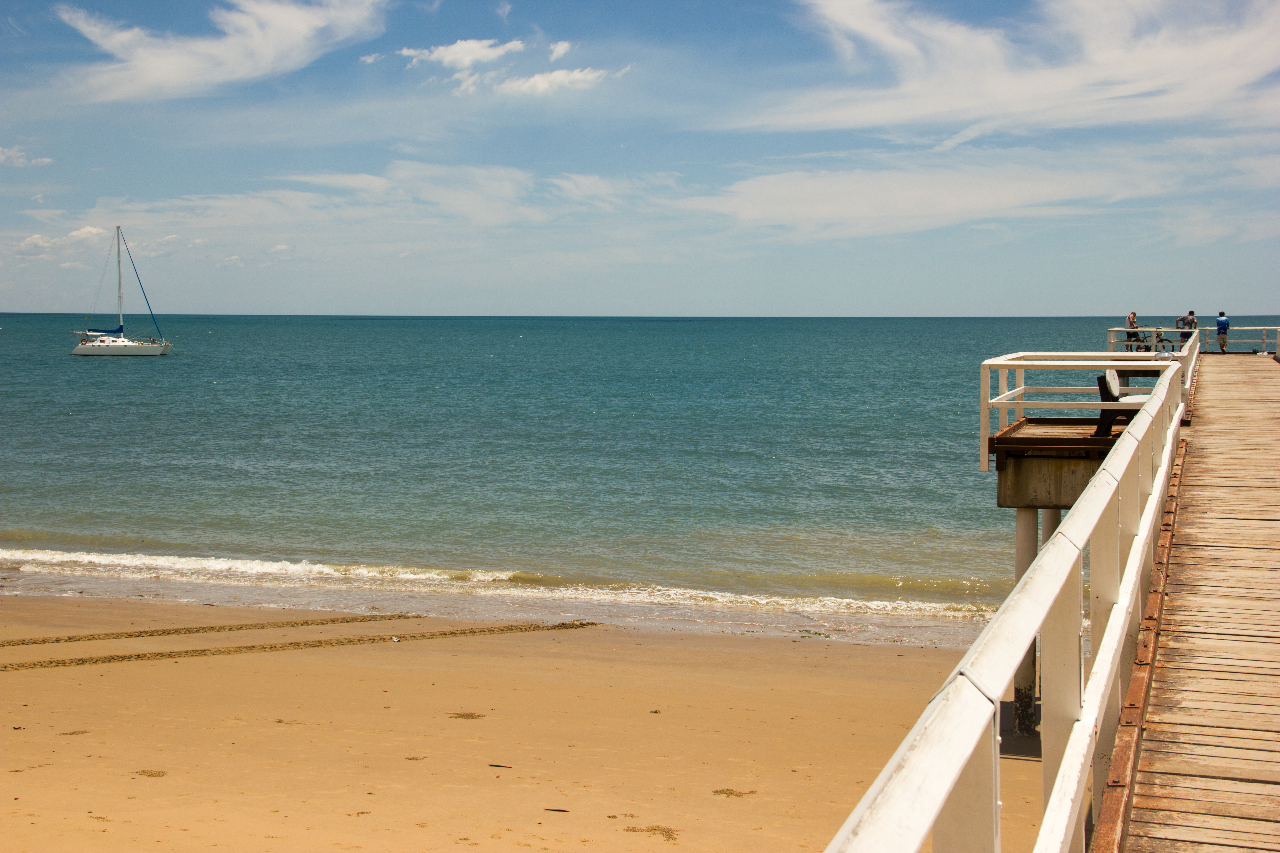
<box><xmin>0</xmin><ymin>0</ymin><xmax>1280</xmax><ymax>318</ymax></box>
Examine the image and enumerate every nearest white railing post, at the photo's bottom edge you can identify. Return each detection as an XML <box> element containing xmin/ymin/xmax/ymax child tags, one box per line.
<box><xmin>933</xmin><ymin>712</ymin><xmax>1000</xmax><ymax>853</ymax></box>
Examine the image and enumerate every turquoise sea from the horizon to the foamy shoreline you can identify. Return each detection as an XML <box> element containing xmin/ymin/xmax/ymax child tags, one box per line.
<box><xmin>0</xmin><ymin>314</ymin><xmax>1274</xmax><ymax>640</ymax></box>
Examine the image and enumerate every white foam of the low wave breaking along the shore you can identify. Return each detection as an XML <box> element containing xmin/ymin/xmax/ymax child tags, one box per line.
<box><xmin>0</xmin><ymin>549</ymin><xmax>996</xmax><ymax>619</ymax></box>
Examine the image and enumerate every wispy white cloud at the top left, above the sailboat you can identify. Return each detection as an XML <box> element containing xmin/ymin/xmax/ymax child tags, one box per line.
<box><xmin>58</xmin><ymin>0</ymin><xmax>389</xmax><ymax>101</ymax></box>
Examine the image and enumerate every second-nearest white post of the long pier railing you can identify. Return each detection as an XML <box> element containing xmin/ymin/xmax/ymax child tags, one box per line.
<box><xmin>1041</xmin><ymin>548</ymin><xmax>1085</xmax><ymax>853</ymax></box>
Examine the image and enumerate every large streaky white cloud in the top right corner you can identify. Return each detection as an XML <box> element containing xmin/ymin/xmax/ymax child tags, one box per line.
<box><xmin>733</xmin><ymin>0</ymin><xmax>1280</xmax><ymax>139</ymax></box>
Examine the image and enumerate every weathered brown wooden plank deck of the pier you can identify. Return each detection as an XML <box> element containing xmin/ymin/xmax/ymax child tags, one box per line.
<box><xmin>1116</xmin><ymin>355</ymin><xmax>1280</xmax><ymax>853</ymax></box>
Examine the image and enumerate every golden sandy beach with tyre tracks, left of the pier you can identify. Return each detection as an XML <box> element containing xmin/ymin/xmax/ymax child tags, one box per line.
<box><xmin>0</xmin><ymin>596</ymin><xmax>1039</xmax><ymax>850</ymax></box>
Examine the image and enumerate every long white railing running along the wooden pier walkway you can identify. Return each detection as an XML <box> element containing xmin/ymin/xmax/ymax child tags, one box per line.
<box><xmin>827</xmin><ymin>353</ymin><xmax>1183</xmax><ymax>853</ymax></box>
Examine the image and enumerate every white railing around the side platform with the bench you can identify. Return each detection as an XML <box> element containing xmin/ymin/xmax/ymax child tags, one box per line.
<box><xmin>978</xmin><ymin>338</ymin><xmax>1201</xmax><ymax>471</ymax></box>
